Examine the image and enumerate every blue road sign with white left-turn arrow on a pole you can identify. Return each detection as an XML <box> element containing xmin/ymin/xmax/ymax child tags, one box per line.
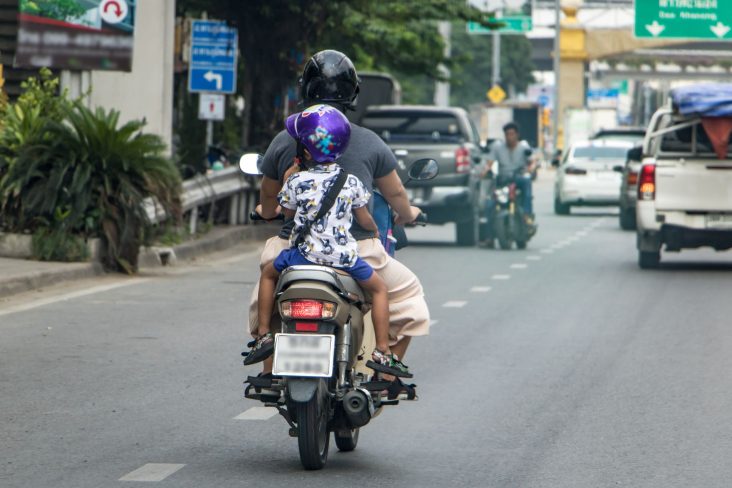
<box><xmin>188</xmin><ymin>20</ymin><xmax>238</xmax><ymax>93</ymax></box>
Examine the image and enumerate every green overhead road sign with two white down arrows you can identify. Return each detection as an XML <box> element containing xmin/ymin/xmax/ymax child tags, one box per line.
<box><xmin>635</xmin><ymin>0</ymin><xmax>732</xmax><ymax>41</ymax></box>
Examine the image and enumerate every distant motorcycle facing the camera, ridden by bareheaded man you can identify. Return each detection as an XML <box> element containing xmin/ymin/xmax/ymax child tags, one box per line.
<box><xmin>485</xmin><ymin>163</ymin><xmax>536</xmax><ymax>249</ymax></box>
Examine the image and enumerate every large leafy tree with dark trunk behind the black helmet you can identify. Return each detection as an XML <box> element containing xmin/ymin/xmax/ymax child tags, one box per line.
<box><xmin>178</xmin><ymin>0</ymin><xmax>493</xmax><ymax>147</ymax></box>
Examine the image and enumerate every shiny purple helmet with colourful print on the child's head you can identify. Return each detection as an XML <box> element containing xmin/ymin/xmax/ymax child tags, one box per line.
<box><xmin>285</xmin><ymin>105</ymin><xmax>351</xmax><ymax>163</ymax></box>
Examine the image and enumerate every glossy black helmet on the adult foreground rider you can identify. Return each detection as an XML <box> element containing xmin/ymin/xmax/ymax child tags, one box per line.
<box><xmin>299</xmin><ymin>49</ymin><xmax>361</xmax><ymax>109</ymax></box>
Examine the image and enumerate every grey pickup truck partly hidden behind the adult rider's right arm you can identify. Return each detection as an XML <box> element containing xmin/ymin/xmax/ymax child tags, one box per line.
<box><xmin>361</xmin><ymin>105</ymin><xmax>484</xmax><ymax>246</ymax></box>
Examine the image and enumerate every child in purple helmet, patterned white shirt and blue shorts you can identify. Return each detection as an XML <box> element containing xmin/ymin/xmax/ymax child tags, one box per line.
<box><xmin>244</xmin><ymin>105</ymin><xmax>411</xmax><ymax>376</ymax></box>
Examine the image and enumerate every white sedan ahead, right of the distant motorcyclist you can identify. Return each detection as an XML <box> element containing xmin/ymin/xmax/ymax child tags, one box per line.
<box><xmin>554</xmin><ymin>140</ymin><xmax>633</xmax><ymax>215</ymax></box>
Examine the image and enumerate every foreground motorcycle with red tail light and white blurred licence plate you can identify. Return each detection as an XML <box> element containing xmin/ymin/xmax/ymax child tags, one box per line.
<box><xmin>240</xmin><ymin>154</ymin><xmax>438</xmax><ymax>470</ymax></box>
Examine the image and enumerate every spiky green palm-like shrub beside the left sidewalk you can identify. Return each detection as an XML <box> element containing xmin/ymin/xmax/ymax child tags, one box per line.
<box><xmin>0</xmin><ymin>102</ymin><xmax>180</xmax><ymax>273</ymax></box>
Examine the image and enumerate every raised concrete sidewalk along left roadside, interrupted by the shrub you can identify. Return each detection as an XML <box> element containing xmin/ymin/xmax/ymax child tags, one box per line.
<box><xmin>0</xmin><ymin>224</ymin><xmax>279</xmax><ymax>298</ymax></box>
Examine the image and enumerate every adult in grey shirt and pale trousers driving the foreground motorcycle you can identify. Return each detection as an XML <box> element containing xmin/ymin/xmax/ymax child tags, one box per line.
<box><xmin>249</xmin><ymin>50</ymin><xmax>430</xmax><ymax>399</ymax></box>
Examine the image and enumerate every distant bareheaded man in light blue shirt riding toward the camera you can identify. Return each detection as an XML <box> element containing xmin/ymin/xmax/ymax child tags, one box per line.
<box><xmin>481</xmin><ymin>122</ymin><xmax>536</xmax><ymax>241</ymax></box>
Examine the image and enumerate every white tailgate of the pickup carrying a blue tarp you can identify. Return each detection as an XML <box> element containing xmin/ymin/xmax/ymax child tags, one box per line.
<box><xmin>656</xmin><ymin>159</ymin><xmax>732</xmax><ymax>212</ymax></box>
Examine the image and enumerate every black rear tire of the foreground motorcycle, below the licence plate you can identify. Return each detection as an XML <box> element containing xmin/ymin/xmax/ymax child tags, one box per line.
<box><xmin>295</xmin><ymin>386</ymin><xmax>330</xmax><ymax>471</ymax></box>
